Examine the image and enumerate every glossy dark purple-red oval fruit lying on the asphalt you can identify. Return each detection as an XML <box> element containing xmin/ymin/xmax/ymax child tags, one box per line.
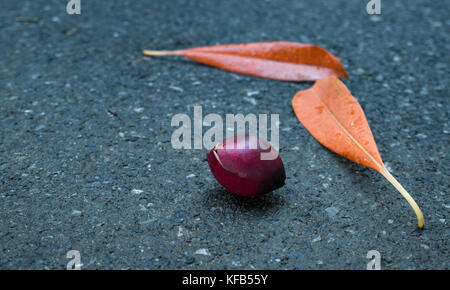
<box><xmin>206</xmin><ymin>135</ymin><xmax>286</xmax><ymax>197</ymax></box>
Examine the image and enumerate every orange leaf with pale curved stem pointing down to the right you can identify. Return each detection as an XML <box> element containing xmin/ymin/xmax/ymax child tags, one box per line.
<box><xmin>292</xmin><ymin>76</ymin><xmax>424</xmax><ymax>228</ymax></box>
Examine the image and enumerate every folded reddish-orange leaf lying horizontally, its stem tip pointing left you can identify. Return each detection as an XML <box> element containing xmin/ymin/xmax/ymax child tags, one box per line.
<box><xmin>143</xmin><ymin>41</ymin><xmax>349</xmax><ymax>81</ymax></box>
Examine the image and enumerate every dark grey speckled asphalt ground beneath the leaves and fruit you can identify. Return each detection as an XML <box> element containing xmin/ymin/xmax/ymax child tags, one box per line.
<box><xmin>0</xmin><ymin>0</ymin><xmax>450</xmax><ymax>269</ymax></box>
